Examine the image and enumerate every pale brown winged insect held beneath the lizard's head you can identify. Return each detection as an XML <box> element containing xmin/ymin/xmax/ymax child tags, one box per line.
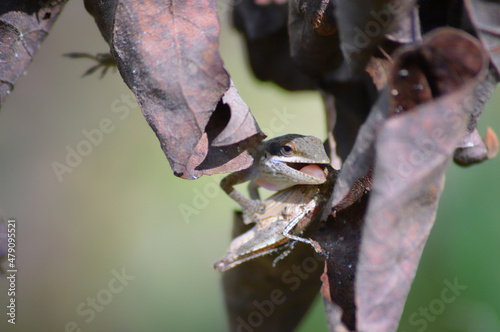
<box><xmin>214</xmin><ymin>165</ymin><xmax>338</xmax><ymax>272</ymax></box>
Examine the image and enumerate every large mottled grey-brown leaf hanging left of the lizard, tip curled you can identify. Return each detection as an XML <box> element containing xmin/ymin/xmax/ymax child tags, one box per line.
<box><xmin>85</xmin><ymin>0</ymin><xmax>264</xmax><ymax>179</ymax></box>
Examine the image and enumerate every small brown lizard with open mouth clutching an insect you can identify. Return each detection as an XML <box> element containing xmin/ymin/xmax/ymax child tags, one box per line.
<box><xmin>220</xmin><ymin>134</ymin><xmax>330</xmax><ymax>224</ymax></box>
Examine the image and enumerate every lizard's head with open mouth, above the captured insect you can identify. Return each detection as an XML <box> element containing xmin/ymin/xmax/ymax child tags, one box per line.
<box><xmin>263</xmin><ymin>134</ymin><xmax>330</xmax><ymax>184</ymax></box>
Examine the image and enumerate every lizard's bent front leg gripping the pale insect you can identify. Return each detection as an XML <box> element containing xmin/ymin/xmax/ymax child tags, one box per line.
<box><xmin>220</xmin><ymin>169</ymin><xmax>266</xmax><ymax>224</ymax></box>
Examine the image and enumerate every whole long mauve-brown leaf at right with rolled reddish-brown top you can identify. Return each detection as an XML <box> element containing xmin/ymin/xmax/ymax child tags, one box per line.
<box><xmin>355</xmin><ymin>29</ymin><xmax>487</xmax><ymax>332</ymax></box>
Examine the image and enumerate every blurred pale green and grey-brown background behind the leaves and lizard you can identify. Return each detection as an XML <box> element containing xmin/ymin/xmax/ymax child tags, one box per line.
<box><xmin>0</xmin><ymin>1</ymin><xmax>500</xmax><ymax>332</ymax></box>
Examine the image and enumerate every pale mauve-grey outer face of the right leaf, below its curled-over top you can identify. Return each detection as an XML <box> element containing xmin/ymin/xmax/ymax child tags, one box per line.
<box><xmin>356</xmin><ymin>103</ymin><xmax>460</xmax><ymax>332</ymax></box>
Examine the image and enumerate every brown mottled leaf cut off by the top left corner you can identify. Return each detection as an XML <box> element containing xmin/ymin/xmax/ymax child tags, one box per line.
<box><xmin>0</xmin><ymin>0</ymin><xmax>66</xmax><ymax>106</ymax></box>
